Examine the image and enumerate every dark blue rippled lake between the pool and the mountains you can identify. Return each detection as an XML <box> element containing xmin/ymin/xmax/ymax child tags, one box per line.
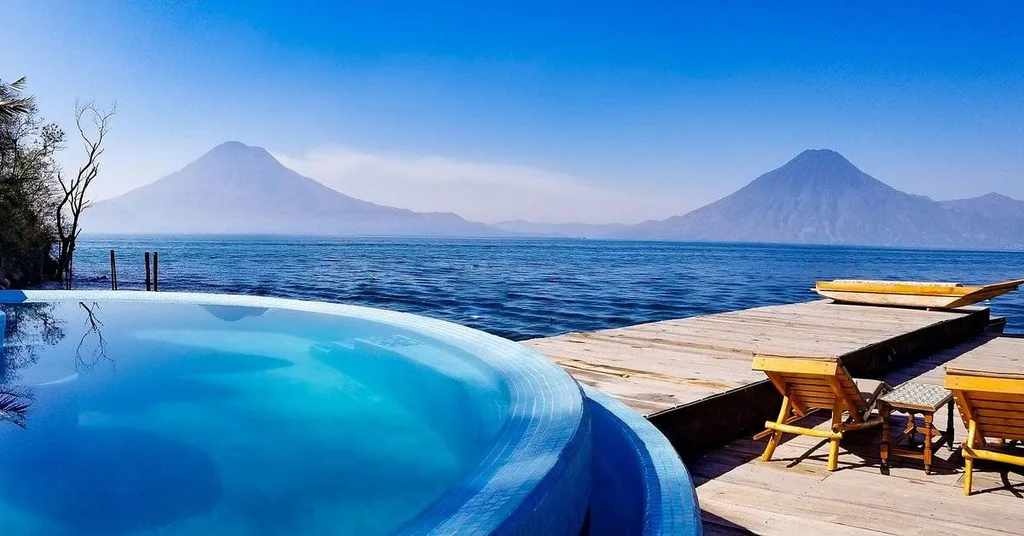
<box><xmin>75</xmin><ymin>236</ymin><xmax>1024</xmax><ymax>340</ymax></box>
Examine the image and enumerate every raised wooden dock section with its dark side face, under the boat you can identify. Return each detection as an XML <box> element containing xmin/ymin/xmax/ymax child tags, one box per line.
<box><xmin>525</xmin><ymin>300</ymin><xmax>989</xmax><ymax>459</ymax></box>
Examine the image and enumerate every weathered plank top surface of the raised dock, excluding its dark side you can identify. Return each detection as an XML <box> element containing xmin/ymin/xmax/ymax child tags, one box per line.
<box><xmin>524</xmin><ymin>300</ymin><xmax>978</xmax><ymax>415</ymax></box>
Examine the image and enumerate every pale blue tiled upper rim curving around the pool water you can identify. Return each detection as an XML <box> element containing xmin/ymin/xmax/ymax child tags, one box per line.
<box><xmin>0</xmin><ymin>290</ymin><xmax>589</xmax><ymax>534</ymax></box>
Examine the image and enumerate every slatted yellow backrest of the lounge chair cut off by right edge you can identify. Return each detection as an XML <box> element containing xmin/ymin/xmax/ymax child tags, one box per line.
<box><xmin>946</xmin><ymin>367</ymin><xmax>1024</xmax><ymax>441</ymax></box>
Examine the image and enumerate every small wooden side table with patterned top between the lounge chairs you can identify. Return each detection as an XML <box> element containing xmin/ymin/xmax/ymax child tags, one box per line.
<box><xmin>879</xmin><ymin>381</ymin><xmax>953</xmax><ymax>475</ymax></box>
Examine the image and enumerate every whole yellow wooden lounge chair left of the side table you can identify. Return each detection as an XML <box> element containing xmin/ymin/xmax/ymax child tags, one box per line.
<box><xmin>754</xmin><ymin>356</ymin><xmax>891</xmax><ymax>470</ymax></box>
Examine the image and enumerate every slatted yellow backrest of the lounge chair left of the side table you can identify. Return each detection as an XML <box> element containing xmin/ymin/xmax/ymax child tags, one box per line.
<box><xmin>753</xmin><ymin>356</ymin><xmax>870</xmax><ymax>420</ymax></box>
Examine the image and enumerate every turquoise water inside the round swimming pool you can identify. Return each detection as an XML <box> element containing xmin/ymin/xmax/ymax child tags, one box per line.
<box><xmin>0</xmin><ymin>301</ymin><xmax>507</xmax><ymax>536</ymax></box>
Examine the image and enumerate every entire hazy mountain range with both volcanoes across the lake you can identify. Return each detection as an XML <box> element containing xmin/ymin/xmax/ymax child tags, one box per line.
<box><xmin>84</xmin><ymin>141</ymin><xmax>1024</xmax><ymax>248</ymax></box>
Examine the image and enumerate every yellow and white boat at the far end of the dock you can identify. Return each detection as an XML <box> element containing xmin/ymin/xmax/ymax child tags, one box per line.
<box><xmin>813</xmin><ymin>279</ymin><xmax>1024</xmax><ymax>308</ymax></box>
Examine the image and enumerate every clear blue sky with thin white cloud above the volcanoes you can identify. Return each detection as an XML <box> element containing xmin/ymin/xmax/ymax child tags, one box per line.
<box><xmin>0</xmin><ymin>0</ymin><xmax>1024</xmax><ymax>222</ymax></box>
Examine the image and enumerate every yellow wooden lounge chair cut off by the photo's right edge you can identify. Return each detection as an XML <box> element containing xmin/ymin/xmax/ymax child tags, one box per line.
<box><xmin>946</xmin><ymin>346</ymin><xmax>1024</xmax><ymax>495</ymax></box>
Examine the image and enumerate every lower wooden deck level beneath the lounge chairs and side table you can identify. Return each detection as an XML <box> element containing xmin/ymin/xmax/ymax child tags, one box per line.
<box><xmin>690</xmin><ymin>336</ymin><xmax>1024</xmax><ymax>535</ymax></box>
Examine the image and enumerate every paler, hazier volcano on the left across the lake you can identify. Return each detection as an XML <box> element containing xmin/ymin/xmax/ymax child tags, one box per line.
<box><xmin>83</xmin><ymin>141</ymin><xmax>506</xmax><ymax>237</ymax></box>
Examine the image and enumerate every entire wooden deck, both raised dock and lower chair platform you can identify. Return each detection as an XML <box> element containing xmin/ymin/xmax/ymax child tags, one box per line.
<box><xmin>526</xmin><ymin>301</ymin><xmax>1024</xmax><ymax>536</ymax></box>
